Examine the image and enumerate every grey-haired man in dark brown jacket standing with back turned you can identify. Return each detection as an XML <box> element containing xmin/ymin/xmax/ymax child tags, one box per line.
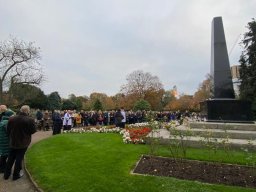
<box><xmin>4</xmin><ymin>105</ymin><xmax>36</xmax><ymax>180</ymax></box>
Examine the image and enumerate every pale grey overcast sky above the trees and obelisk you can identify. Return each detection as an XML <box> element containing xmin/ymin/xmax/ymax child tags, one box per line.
<box><xmin>0</xmin><ymin>0</ymin><xmax>256</xmax><ymax>98</ymax></box>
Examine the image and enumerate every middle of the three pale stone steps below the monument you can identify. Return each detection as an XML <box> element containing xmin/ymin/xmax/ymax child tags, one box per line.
<box><xmin>170</xmin><ymin>125</ymin><xmax>256</xmax><ymax>140</ymax></box>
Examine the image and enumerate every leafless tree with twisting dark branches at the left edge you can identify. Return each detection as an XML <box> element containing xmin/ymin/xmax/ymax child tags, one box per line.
<box><xmin>0</xmin><ymin>38</ymin><xmax>43</xmax><ymax>102</ymax></box>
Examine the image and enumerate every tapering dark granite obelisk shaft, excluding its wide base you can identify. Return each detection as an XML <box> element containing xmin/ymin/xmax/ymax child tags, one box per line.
<box><xmin>211</xmin><ymin>17</ymin><xmax>235</xmax><ymax>99</ymax></box>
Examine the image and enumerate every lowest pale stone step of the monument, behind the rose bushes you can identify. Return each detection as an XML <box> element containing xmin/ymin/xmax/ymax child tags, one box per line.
<box><xmin>147</xmin><ymin>129</ymin><xmax>256</xmax><ymax>150</ymax></box>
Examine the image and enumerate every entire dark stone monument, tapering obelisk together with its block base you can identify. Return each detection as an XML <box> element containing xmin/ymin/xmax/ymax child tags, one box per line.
<box><xmin>200</xmin><ymin>17</ymin><xmax>253</xmax><ymax>122</ymax></box>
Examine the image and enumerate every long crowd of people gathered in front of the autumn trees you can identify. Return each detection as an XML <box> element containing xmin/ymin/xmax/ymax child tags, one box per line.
<box><xmin>34</xmin><ymin>108</ymin><xmax>200</xmax><ymax>135</ymax></box>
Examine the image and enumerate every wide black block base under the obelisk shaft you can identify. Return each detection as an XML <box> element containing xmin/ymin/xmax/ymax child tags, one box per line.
<box><xmin>200</xmin><ymin>99</ymin><xmax>254</xmax><ymax>123</ymax></box>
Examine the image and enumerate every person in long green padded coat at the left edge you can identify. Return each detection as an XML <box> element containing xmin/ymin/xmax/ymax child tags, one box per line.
<box><xmin>0</xmin><ymin>107</ymin><xmax>14</xmax><ymax>173</ymax></box>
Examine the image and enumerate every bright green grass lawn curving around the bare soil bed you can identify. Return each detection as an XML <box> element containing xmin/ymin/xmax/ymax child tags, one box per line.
<box><xmin>26</xmin><ymin>133</ymin><xmax>256</xmax><ymax>192</ymax></box>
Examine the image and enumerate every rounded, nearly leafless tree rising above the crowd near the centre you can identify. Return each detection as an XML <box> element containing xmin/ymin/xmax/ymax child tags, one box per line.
<box><xmin>121</xmin><ymin>70</ymin><xmax>163</xmax><ymax>99</ymax></box>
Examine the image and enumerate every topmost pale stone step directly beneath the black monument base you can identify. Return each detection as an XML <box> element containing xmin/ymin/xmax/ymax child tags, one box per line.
<box><xmin>187</xmin><ymin>121</ymin><xmax>256</xmax><ymax>131</ymax></box>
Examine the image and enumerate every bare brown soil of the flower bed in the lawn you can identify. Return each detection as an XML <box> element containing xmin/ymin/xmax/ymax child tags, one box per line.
<box><xmin>134</xmin><ymin>156</ymin><xmax>256</xmax><ymax>188</ymax></box>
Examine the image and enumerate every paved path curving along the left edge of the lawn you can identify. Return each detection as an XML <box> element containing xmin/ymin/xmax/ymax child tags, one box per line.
<box><xmin>0</xmin><ymin>131</ymin><xmax>52</xmax><ymax>192</ymax></box>
